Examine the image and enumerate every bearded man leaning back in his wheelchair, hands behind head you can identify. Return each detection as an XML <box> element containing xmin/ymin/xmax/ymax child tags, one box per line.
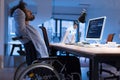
<box><xmin>11</xmin><ymin>0</ymin><xmax>81</xmax><ymax>80</ymax></box>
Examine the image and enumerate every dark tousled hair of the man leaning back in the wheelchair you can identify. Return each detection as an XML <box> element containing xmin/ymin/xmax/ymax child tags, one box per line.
<box><xmin>10</xmin><ymin>0</ymin><xmax>27</xmax><ymax>17</ymax></box>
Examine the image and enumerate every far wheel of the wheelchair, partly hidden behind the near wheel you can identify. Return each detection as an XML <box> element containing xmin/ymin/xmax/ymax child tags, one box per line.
<box><xmin>14</xmin><ymin>62</ymin><xmax>27</xmax><ymax>80</ymax></box>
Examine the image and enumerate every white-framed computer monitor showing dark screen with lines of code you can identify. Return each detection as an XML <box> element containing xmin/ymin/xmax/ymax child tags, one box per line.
<box><xmin>86</xmin><ymin>16</ymin><xmax>106</xmax><ymax>40</ymax></box>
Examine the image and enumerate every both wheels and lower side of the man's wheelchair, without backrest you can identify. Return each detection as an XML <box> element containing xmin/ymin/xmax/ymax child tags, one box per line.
<box><xmin>14</xmin><ymin>58</ymin><xmax>63</xmax><ymax>80</ymax></box>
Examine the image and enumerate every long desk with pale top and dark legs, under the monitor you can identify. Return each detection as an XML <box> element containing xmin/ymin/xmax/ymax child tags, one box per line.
<box><xmin>50</xmin><ymin>43</ymin><xmax>120</xmax><ymax>80</ymax></box>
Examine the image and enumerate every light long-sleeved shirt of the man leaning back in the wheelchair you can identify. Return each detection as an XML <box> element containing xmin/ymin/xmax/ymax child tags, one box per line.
<box><xmin>13</xmin><ymin>9</ymin><xmax>49</xmax><ymax>57</ymax></box>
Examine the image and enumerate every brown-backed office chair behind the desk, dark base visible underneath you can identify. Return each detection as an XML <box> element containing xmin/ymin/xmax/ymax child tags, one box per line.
<box><xmin>100</xmin><ymin>33</ymin><xmax>120</xmax><ymax>80</ymax></box>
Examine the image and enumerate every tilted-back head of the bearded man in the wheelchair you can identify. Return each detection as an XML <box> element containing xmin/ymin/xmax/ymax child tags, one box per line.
<box><xmin>10</xmin><ymin>0</ymin><xmax>35</xmax><ymax>21</ymax></box>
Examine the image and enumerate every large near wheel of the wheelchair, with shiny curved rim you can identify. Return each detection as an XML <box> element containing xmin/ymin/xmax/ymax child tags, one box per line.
<box><xmin>17</xmin><ymin>63</ymin><xmax>61</xmax><ymax>80</ymax></box>
